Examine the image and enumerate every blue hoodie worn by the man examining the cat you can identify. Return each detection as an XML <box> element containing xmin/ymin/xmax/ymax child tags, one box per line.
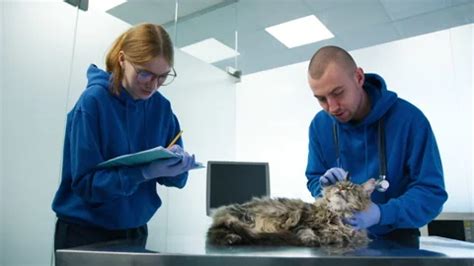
<box><xmin>306</xmin><ymin>74</ymin><xmax>447</xmax><ymax>236</ymax></box>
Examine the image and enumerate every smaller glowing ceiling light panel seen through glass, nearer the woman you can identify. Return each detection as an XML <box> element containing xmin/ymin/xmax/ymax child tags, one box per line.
<box><xmin>181</xmin><ymin>38</ymin><xmax>239</xmax><ymax>63</ymax></box>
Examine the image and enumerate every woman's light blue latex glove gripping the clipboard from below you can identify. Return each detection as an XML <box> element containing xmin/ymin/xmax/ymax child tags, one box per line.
<box><xmin>142</xmin><ymin>145</ymin><xmax>196</xmax><ymax>180</ymax></box>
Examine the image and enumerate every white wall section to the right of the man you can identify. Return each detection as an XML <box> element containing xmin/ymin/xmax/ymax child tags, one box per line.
<box><xmin>352</xmin><ymin>24</ymin><xmax>474</xmax><ymax>212</ymax></box>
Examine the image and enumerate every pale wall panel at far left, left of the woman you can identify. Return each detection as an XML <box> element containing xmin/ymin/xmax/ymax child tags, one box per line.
<box><xmin>0</xmin><ymin>1</ymin><xmax>74</xmax><ymax>265</ymax></box>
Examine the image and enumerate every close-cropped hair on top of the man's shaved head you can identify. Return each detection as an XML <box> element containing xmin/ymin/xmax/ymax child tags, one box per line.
<box><xmin>308</xmin><ymin>46</ymin><xmax>357</xmax><ymax>79</ymax></box>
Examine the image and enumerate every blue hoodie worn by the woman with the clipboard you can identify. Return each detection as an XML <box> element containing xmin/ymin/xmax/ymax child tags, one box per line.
<box><xmin>53</xmin><ymin>65</ymin><xmax>188</xmax><ymax>230</ymax></box>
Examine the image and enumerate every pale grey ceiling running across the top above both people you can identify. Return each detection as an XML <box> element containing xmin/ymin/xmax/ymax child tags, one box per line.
<box><xmin>108</xmin><ymin>0</ymin><xmax>474</xmax><ymax>75</ymax></box>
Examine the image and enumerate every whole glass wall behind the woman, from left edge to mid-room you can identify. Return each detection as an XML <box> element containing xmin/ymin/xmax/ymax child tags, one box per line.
<box><xmin>0</xmin><ymin>0</ymin><xmax>235</xmax><ymax>266</ymax></box>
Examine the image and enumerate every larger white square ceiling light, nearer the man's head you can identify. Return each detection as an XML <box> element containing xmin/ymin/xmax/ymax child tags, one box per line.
<box><xmin>265</xmin><ymin>15</ymin><xmax>334</xmax><ymax>48</ymax></box>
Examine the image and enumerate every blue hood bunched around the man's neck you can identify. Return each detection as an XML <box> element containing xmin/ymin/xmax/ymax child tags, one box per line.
<box><xmin>337</xmin><ymin>74</ymin><xmax>397</xmax><ymax>127</ymax></box>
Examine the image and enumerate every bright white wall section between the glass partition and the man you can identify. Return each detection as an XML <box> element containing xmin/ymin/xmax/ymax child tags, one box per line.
<box><xmin>236</xmin><ymin>62</ymin><xmax>320</xmax><ymax>201</ymax></box>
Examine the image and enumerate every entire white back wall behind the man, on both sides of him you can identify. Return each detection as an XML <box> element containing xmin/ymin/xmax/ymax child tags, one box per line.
<box><xmin>237</xmin><ymin>22</ymin><xmax>474</xmax><ymax>212</ymax></box>
